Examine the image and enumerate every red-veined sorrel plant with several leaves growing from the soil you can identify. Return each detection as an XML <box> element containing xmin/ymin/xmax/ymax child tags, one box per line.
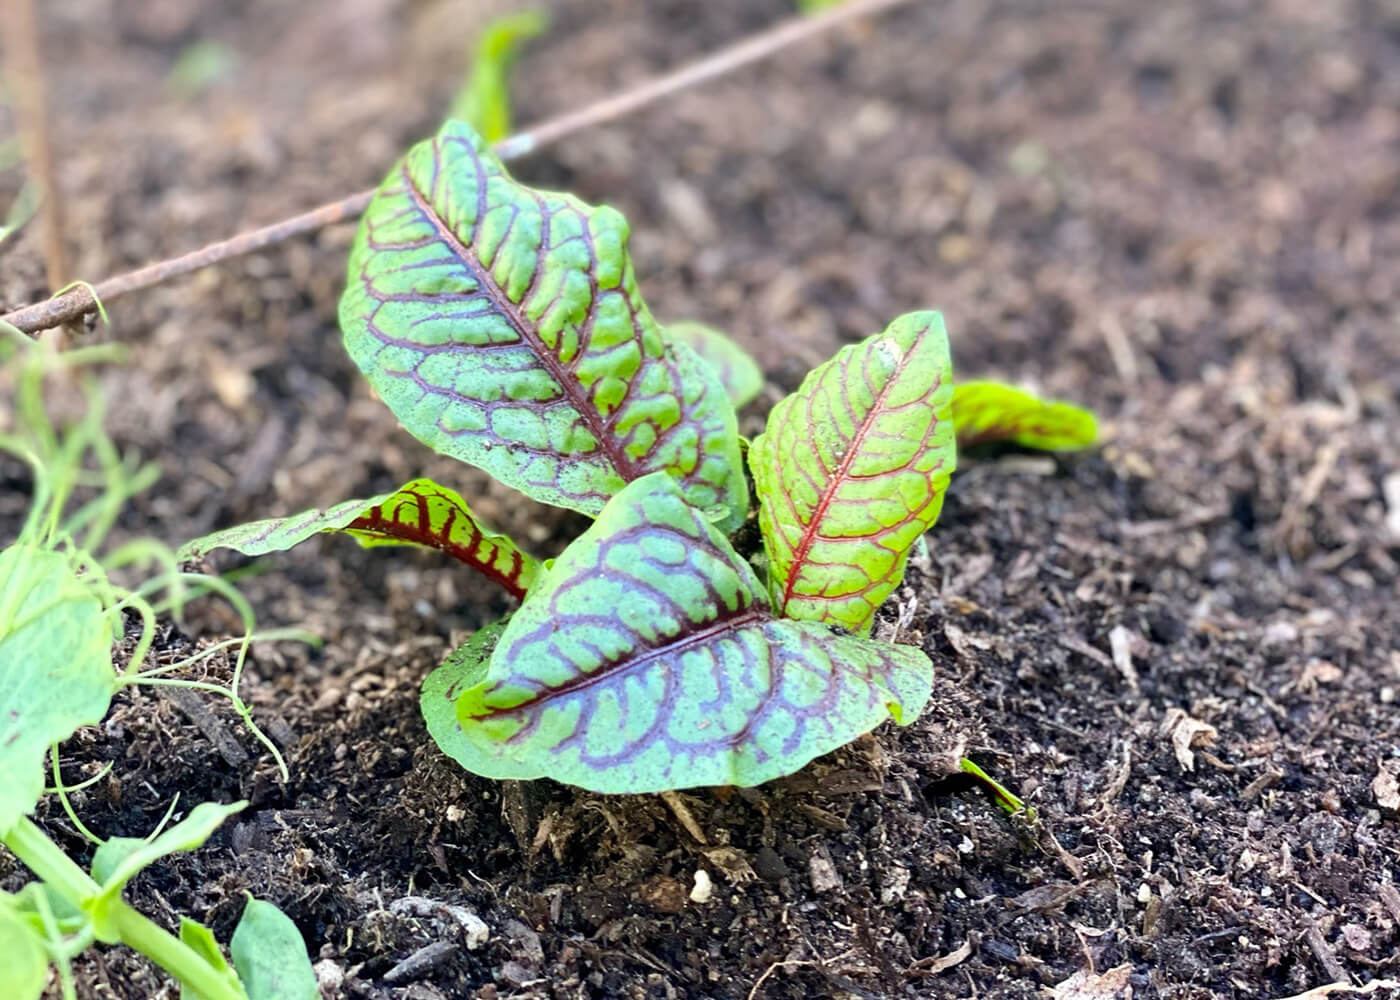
<box><xmin>183</xmin><ymin>122</ymin><xmax>1097</xmax><ymax>793</ymax></box>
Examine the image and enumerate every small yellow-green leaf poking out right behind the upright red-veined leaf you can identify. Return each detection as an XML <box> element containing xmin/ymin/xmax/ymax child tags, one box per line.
<box><xmin>953</xmin><ymin>382</ymin><xmax>1099</xmax><ymax>451</ymax></box>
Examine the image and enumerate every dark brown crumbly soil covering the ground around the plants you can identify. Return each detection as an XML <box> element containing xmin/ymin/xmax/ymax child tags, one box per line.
<box><xmin>0</xmin><ymin>0</ymin><xmax>1400</xmax><ymax>1000</ymax></box>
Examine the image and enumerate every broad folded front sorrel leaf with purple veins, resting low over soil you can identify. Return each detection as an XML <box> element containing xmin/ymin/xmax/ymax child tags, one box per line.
<box><xmin>426</xmin><ymin>473</ymin><xmax>932</xmax><ymax>793</ymax></box>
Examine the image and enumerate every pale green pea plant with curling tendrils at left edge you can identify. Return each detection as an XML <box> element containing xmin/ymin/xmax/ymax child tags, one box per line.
<box><xmin>0</xmin><ymin>333</ymin><xmax>316</xmax><ymax>1000</ymax></box>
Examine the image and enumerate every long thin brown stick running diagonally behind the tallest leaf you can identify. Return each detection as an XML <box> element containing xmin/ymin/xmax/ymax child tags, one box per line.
<box><xmin>0</xmin><ymin>0</ymin><xmax>911</xmax><ymax>336</ymax></box>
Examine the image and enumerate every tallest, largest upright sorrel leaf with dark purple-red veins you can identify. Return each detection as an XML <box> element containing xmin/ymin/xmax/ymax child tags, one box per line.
<box><xmin>340</xmin><ymin>122</ymin><xmax>748</xmax><ymax>529</ymax></box>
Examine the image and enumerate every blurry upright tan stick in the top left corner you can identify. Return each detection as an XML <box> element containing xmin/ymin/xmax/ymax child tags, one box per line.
<box><xmin>3</xmin><ymin>0</ymin><xmax>69</xmax><ymax>291</ymax></box>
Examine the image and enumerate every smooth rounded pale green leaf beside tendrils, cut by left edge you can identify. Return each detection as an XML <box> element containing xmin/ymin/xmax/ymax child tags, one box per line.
<box><xmin>0</xmin><ymin>545</ymin><xmax>116</xmax><ymax>836</ymax></box>
